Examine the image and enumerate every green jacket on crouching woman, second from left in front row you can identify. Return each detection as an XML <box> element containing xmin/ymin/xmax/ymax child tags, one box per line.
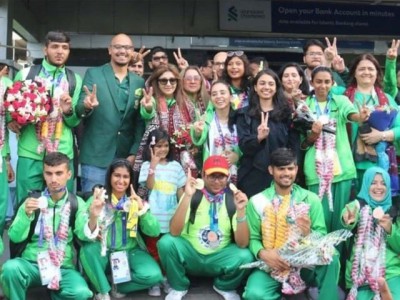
<box><xmin>87</xmin><ymin>196</ymin><xmax>160</xmax><ymax>251</ymax></box>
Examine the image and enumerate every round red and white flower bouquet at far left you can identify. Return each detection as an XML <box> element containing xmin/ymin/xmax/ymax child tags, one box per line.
<box><xmin>4</xmin><ymin>80</ymin><xmax>52</xmax><ymax>125</ymax></box>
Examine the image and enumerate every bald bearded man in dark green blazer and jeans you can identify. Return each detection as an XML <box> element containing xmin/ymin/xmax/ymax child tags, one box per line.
<box><xmin>76</xmin><ymin>34</ymin><xmax>144</xmax><ymax>192</ymax></box>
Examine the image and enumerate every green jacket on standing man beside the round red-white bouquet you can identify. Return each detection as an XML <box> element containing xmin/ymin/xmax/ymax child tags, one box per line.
<box><xmin>9</xmin><ymin>59</ymin><xmax>82</xmax><ymax>160</ymax></box>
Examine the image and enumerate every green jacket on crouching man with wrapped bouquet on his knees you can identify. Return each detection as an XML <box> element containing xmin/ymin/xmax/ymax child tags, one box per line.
<box><xmin>246</xmin><ymin>182</ymin><xmax>326</xmax><ymax>258</ymax></box>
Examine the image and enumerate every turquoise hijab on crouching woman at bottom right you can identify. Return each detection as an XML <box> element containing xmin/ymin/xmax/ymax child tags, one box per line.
<box><xmin>357</xmin><ymin>167</ymin><xmax>392</xmax><ymax>213</ymax></box>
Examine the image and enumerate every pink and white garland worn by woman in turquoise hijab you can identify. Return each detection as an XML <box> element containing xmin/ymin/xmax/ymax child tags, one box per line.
<box><xmin>347</xmin><ymin>205</ymin><xmax>386</xmax><ymax>300</ymax></box>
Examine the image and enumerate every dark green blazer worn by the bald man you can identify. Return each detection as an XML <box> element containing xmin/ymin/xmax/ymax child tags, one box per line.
<box><xmin>76</xmin><ymin>63</ymin><xmax>144</xmax><ymax>168</ymax></box>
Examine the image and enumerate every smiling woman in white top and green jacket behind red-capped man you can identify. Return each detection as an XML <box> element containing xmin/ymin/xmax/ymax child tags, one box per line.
<box><xmin>190</xmin><ymin>80</ymin><xmax>240</xmax><ymax>184</ymax></box>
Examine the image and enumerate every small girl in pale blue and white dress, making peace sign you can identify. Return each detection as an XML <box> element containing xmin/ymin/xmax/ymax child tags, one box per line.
<box><xmin>139</xmin><ymin>129</ymin><xmax>186</xmax><ymax>296</ymax></box>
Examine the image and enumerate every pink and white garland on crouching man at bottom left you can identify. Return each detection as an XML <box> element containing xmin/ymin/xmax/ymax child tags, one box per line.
<box><xmin>41</xmin><ymin>201</ymin><xmax>71</xmax><ymax>290</ymax></box>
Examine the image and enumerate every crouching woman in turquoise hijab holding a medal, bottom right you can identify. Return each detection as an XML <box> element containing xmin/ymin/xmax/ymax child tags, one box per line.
<box><xmin>342</xmin><ymin>167</ymin><xmax>400</xmax><ymax>300</ymax></box>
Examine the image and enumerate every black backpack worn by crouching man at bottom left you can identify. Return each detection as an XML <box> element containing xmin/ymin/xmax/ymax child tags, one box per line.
<box><xmin>10</xmin><ymin>191</ymin><xmax>80</xmax><ymax>258</ymax></box>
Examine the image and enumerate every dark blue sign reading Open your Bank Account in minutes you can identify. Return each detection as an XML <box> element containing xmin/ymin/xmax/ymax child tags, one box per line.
<box><xmin>271</xmin><ymin>1</ymin><xmax>400</xmax><ymax>36</ymax></box>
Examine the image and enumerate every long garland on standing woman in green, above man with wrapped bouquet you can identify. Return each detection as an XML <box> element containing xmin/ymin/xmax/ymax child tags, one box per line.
<box><xmin>315</xmin><ymin>120</ymin><xmax>336</xmax><ymax>211</ymax></box>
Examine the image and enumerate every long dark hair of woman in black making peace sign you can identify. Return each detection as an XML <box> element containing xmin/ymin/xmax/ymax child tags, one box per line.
<box><xmin>249</xmin><ymin>69</ymin><xmax>291</xmax><ymax>121</ymax></box>
